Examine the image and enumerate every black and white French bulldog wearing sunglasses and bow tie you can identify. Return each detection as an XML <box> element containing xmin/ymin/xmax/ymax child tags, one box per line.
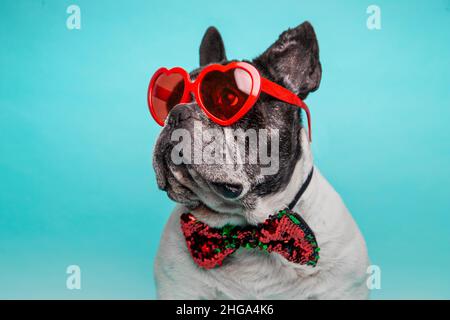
<box><xmin>153</xmin><ymin>22</ymin><xmax>369</xmax><ymax>299</ymax></box>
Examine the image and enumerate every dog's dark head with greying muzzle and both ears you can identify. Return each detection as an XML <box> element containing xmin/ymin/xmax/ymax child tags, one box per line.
<box><xmin>153</xmin><ymin>22</ymin><xmax>322</xmax><ymax>223</ymax></box>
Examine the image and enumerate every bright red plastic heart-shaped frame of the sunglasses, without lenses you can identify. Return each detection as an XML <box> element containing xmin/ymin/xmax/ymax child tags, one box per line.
<box><xmin>147</xmin><ymin>61</ymin><xmax>311</xmax><ymax>141</ymax></box>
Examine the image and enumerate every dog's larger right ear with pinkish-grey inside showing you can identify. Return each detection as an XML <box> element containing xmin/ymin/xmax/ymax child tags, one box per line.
<box><xmin>253</xmin><ymin>22</ymin><xmax>322</xmax><ymax>99</ymax></box>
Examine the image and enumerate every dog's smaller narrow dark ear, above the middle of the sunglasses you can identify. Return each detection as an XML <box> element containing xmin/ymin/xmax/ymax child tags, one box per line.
<box><xmin>200</xmin><ymin>27</ymin><xmax>227</xmax><ymax>66</ymax></box>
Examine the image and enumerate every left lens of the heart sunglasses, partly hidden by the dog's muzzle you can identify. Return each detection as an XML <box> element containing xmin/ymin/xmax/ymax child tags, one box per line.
<box><xmin>150</xmin><ymin>73</ymin><xmax>185</xmax><ymax>122</ymax></box>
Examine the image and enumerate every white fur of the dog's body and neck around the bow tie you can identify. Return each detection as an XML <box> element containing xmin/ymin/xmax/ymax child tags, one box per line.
<box><xmin>155</xmin><ymin>130</ymin><xmax>369</xmax><ymax>299</ymax></box>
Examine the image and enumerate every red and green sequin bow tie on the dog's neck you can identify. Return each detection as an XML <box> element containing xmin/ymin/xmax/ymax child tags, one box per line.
<box><xmin>181</xmin><ymin>209</ymin><xmax>320</xmax><ymax>269</ymax></box>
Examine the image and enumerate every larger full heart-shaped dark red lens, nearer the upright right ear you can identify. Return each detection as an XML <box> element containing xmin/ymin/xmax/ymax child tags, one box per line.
<box><xmin>200</xmin><ymin>68</ymin><xmax>253</xmax><ymax>120</ymax></box>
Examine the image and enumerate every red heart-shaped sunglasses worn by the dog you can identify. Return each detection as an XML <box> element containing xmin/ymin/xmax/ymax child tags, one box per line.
<box><xmin>147</xmin><ymin>62</ymin><xmax>311</xmax><ymax>140</ymax></box>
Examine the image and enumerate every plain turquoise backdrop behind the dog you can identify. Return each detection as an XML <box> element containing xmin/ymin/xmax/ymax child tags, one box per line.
<box><xmin>0</xmin><ymin>0</ymin><xmax>450</xmax><ymax>299</ymax></box>
